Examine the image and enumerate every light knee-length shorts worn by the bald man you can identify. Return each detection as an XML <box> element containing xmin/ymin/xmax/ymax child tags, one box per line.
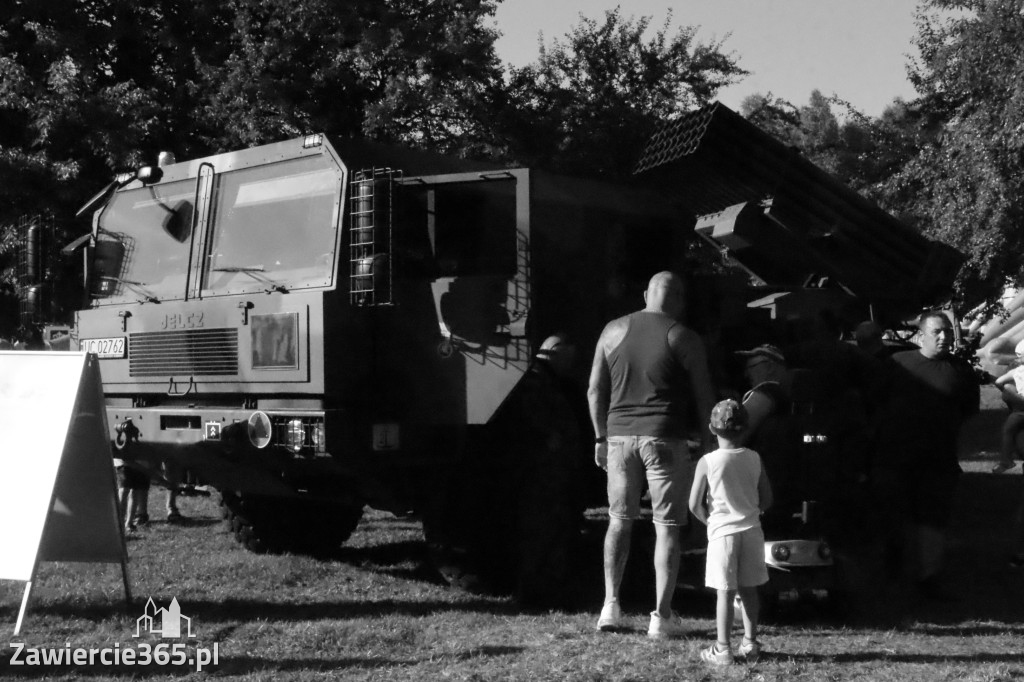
<box><xmin>608</xmin><ymin>436</ymin><xmax>693</xmax><ymax>526</ymax></box>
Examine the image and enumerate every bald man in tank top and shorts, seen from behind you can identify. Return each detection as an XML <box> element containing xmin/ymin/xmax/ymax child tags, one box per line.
<box><xmin>587</xmin><ymin>272</ymin><xmax>715</xmax><ymax>638</ymax></box>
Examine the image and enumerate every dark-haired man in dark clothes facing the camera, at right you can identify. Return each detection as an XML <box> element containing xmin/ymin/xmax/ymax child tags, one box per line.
<box><xmin>873</xmin><ymin>311</ymin><xmax>980</xmax><ymax>599</ymax></box>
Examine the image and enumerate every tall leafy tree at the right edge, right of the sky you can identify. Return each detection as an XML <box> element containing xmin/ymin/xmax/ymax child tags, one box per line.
<box><xmin>885</xmin><ymin>0</ymin><xmax>1024</xmax><ymax>304</ymax></box>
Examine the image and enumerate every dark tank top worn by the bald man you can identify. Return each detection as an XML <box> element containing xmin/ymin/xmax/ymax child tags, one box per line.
<box><xmin>607</xmin><ymin>310</ymin><xmax>688</xmax><ymax>438</ymax></box>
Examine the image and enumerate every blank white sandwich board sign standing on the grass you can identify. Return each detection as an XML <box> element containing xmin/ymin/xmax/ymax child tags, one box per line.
<box><xmin>0</xmin><ymin>351</ymin><xmax>131</xmax><ymax>635</ymax></box>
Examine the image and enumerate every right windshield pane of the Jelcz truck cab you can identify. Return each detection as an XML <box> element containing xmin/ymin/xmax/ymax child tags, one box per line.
<box><xmin>202</xmin><ymin>155</ymin><xmax>343</xmax><ymax>296</ymax></box>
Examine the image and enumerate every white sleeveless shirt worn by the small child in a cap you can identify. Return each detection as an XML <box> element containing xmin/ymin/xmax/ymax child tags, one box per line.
<box><xmin>703</xmin><ymin>447</ymin><xmax>762</xmax><ymax>540</ymax></box>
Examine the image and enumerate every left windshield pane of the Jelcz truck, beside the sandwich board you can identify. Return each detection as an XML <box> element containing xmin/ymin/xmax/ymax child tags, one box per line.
<box><xmin>93</xmin><ymin>180</ymin><xmax>196</xmax><ymax>300</ymax></box>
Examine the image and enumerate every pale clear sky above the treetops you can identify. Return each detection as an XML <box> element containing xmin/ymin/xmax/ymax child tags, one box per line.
<box><xmin>495</xmin><ymin>0</ymin><xmax>916</xmax><ymax>116</ymax></box>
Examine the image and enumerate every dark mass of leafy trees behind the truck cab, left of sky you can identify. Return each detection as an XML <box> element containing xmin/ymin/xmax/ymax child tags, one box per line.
<box><xmin>0</xmin><ymin>0</ymin><xmax>501</xmax><ymax>329</ymax></box>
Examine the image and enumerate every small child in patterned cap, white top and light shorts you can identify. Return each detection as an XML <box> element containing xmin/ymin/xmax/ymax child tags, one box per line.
<box><xmin>689</xmin><ymin>399</ymin><xmax>771</xmax><ymax>666</ymax></box>
